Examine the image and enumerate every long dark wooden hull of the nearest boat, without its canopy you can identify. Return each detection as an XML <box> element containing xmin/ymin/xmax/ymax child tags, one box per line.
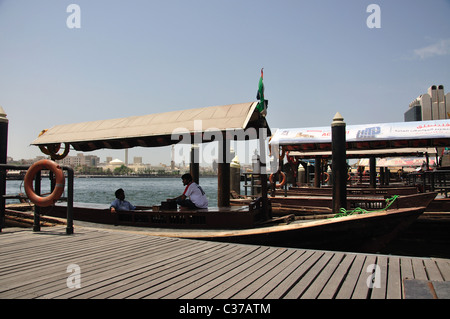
<box><xmin>33</xmin><ymin>201</ymin><xmax>426</xmax><ymax>252</ymax></box>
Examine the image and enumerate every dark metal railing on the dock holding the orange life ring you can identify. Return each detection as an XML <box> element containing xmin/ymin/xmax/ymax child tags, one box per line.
<box><xmin>0</xmin><ymin>164</ymin><xmax>74</xmax><ymax>235</ymax></box>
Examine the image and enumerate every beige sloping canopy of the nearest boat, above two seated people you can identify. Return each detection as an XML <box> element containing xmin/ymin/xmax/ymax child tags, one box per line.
<box><xmin>31</xmin><ymin>102</ymin><xmax>271</xmax><ymax>152</ymax></box>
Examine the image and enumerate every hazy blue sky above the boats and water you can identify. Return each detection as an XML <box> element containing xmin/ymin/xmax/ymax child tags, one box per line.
<box><xmin>0</xmin><ymin>0</ymin><xmax>450</xmax><ymax>165</ymax></box>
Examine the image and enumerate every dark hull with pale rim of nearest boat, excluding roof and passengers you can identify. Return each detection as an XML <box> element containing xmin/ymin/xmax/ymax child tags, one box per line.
<box><xmin>37</xmin><ymin>204</ymin><xmax>426</xmax><ymax>252</ymax></box>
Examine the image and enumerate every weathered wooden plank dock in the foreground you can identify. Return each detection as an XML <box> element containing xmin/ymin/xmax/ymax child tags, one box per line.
<box><xmin>0</xmin><ymin>226</ymin><xmax>450</xmax><ymax>299</ymax></box>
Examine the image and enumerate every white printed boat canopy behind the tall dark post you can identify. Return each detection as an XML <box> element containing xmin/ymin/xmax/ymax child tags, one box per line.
<box><xmin>269</xmin><ymin>120</ymin><xmax>450</xmax><ymax>158</ymax></box>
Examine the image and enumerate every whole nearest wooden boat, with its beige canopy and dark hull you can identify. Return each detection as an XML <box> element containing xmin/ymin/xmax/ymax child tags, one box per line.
<box><xmin>0</xmin><ymin>102</ymin><xmax>440</xmax><ymax>249</ymax></box>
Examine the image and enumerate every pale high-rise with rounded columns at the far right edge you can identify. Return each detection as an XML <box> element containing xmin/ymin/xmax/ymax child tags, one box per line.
<box><xmin>405</xmin><ymin>85</ymin><xmax>450</xmax><ymax>122</ymax></box>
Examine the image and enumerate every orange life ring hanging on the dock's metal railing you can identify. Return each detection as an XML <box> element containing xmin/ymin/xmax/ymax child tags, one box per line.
<box><xmin>24</xmin><ymin>159</ymin><xmax>66</xmax><ymax>207</ymax></box>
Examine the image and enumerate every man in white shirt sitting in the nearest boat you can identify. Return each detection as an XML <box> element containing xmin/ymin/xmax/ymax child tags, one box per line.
<box><xmin>168</xmin><ymin>174</ymin><xmax>208</xmax><ymax>209</ymax></box>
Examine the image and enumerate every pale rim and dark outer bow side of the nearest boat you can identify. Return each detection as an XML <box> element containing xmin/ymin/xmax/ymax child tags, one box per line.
<box><xmin>176</xmin><ymin>207</ymin><xmax>425</xmax><ymax>252</ymax></box>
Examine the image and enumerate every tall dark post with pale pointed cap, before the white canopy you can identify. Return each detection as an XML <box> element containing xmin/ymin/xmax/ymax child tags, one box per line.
<box><xmin>331</xmin><ymin>113</ymin><xmax>347</xmax><ymax>214</ymax></box>
